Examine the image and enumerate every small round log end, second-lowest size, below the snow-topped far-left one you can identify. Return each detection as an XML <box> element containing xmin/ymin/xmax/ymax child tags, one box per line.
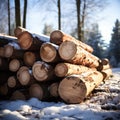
<box><xmin>9</xmin><ymin>59</ymin><xmax>23</xmax><ymax>72</ymax></box>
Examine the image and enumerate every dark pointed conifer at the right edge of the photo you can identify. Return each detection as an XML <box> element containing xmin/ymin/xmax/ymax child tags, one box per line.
<box><xmin>109</xmin><ymin>19</ymin><xmax>120</xmax><ymax>64</ymax></box>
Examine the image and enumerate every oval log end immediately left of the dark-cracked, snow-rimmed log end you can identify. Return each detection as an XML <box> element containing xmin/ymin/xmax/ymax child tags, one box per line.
<box><xmin>17</xmin><ymin>66</ymin><xmax>35</xmax><ymax>86</ymax></box>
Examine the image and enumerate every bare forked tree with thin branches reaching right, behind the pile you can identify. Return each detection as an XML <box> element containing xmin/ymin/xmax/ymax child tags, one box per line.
<box><xmin>76</xmin><ymin>0</ymin><xmax>106</xmax><ymax>41</ymax></box>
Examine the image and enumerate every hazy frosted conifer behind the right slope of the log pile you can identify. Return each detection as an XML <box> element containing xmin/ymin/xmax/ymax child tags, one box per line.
<box><xmin>87</xmin><ymin>24</ymin><xmax>105</xmax><ymax>58</ymax></box>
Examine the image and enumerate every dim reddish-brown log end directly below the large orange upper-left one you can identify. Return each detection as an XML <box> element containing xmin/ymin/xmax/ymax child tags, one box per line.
<box><xmin>23</xmin><ymin>51</ymin><xmax>40</xmax><ymax>67</ymax></box>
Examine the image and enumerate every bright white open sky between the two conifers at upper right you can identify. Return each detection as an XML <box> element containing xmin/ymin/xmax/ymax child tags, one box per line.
<box><xmin>98</xmin><ymin>0</ymin><xmax>120</xmax><ymax>43</ymax></box>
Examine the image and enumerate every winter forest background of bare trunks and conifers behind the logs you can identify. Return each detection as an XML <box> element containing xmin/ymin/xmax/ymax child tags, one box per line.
<box><xmin>0</xmin><ymin>0</ymin><xmax>120</xmax><ymax>67</ymax></box>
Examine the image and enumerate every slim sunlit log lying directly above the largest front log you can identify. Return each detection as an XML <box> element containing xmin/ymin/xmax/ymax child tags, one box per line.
<box><xmin>55</xmin><ymin>63</ymin><xmax>96</xmax><ymax>77</ymax></box>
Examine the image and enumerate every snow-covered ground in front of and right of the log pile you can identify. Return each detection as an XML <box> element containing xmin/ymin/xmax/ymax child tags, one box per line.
<box><xmin>0</xmin><ymin>68</ymin><xmax>120</xmax><ymax>120</ymax></box>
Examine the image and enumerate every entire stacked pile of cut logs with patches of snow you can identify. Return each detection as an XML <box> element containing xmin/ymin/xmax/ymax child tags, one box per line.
<box><xmin>0</xmin><ymin>27</ymin><xmax>112</xmax><ymax>103</ymax></box>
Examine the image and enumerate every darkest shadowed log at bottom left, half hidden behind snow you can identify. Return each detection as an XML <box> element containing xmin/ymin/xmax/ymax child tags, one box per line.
<box><xmin>10</xmin><ymin>89</ymin><xmax>30</xmax><ymax>100</ymax></box>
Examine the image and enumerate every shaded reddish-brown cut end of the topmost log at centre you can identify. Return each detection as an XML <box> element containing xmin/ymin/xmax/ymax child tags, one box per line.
<box><xmin>50</xmin><ymin>30</ymin><xmax>63</xmax><ymax>45</ymax></box>
